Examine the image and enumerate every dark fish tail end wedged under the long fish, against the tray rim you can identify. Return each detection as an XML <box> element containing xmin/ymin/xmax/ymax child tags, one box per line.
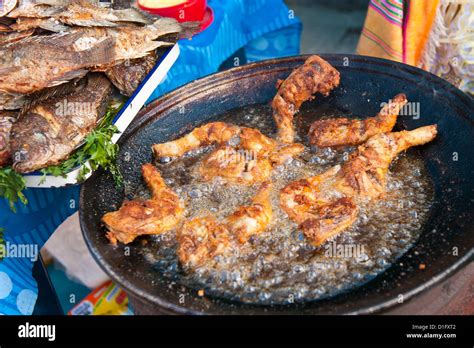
<box><xmin>105</xmin><ymin>52</ymin><xmax>157</xmax><ymax>97</ymax></box>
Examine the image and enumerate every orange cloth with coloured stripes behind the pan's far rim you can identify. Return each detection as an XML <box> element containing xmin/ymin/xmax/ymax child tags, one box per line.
<box><xmin>357</xmin><ymin>0</ymin><xmax>439</xmax><ymax>66</ymax></box>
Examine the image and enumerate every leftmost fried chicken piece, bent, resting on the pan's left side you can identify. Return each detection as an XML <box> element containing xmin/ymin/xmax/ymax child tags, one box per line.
<box><xmin>102</xmin><ymin>163</ymin><xmax>184</xmax><ymax>244</ymax></box>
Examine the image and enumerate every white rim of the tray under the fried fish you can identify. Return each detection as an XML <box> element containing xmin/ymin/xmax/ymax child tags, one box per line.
<box><xmin>23</xmin><ymin>44</ymin><xmax>179</xmax><ymax>188</ymax></box>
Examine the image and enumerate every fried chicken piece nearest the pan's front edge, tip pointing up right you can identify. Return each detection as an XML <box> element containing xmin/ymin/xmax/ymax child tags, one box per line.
<box><xmin>177</xmin><ymin>182</ymin><xmax>272</xmax><ymax>269</ymax></box>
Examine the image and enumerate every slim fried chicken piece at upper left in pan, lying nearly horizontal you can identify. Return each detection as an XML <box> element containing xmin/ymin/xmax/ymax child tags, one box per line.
<box><xmin>153</xmin><ymin>122</ymin><xmax>240</xmax><ymax>158</ymax></box>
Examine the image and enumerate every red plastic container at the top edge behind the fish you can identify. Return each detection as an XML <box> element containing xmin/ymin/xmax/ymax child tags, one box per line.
<box><xmin>138</xmin><ymin>0</ymin><xmax>207</xmax><ymax>22</ymax></box>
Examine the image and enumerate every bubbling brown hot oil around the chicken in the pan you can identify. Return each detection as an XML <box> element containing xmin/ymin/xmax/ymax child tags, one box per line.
<box><xmin>137</xmin><ymin>106</ymin><xmax>432</xmax><ymax>304</ymax></box>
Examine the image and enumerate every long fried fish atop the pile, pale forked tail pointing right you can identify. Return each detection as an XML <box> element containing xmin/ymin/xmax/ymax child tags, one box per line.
<box><xmin>0</xmin><ymin>18</ymin><xmax>181</xmax><ymax>94</ymax></box>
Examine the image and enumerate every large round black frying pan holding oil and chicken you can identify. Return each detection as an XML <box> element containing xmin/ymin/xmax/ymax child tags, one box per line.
<box><xmin>80</xmin><ymin>55</ymin><xmax>474</xmax><ymax>314</ymax></box>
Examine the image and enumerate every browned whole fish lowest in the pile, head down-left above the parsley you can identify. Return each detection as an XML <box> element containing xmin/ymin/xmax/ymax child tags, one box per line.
<box><xmin>10</xmin><ymin>73</ymin><xmax>112</xmax><ymax>173</ymax></box>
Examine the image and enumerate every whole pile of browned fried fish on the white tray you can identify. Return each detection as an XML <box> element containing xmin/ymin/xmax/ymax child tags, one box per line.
<box><xmin>0</xmin><ymin>0</ymin><xmax>187</xmax><ymax>173</ymax></box>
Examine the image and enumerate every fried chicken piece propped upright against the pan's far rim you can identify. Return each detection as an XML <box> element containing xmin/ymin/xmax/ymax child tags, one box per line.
<box><xmin>272</xmin><ymin>55</ymin><xmax>339</xmax><ymax>143</ymax></box>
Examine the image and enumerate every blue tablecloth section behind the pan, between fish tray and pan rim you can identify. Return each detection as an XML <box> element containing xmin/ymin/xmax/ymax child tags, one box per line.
<box><xmin>149</xmin><ymin>0</ymin><xmax>301</xmax><ymax>101</ymax></box>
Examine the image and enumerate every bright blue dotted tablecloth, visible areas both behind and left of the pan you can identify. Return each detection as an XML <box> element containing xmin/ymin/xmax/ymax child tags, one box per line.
<box><xmin>0</xmin><ymin>0</ymin><xmax>301</xmax><ymax>314</ymax></box>
